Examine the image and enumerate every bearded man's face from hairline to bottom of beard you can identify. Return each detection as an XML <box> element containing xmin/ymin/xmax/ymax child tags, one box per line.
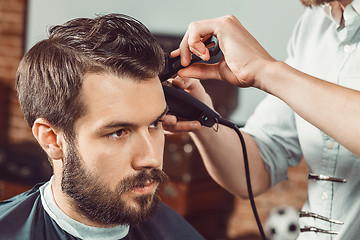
<box><xmin>62</xmin><ymin>73</ymin><xmax>167</xmax><ymax>225</ymax></box>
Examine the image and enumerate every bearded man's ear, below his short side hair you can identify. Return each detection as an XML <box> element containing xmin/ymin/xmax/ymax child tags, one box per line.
<box><xmin>32</xmin><ymin>118</ymin><xmax>64</xmax><ymax>160</ymax></box>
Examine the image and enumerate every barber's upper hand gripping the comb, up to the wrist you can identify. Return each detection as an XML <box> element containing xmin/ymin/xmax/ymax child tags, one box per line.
<box><xmin>171</xmin><ymin>16</ymin><xmax>275</xmax><ymax>88</ymax></box>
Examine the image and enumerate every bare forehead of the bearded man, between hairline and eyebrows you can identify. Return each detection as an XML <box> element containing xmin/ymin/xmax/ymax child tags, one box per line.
<box><xmin>77</xmin><ymin>73</ymin><xmax>166</xmax><ymax>129</ymax></box>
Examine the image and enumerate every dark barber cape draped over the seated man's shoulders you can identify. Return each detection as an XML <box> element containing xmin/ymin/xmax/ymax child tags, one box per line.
<box><xmin>0</xmin><ymin>184</ymin><xmax>204</xmax><ymax>240</ymax></box>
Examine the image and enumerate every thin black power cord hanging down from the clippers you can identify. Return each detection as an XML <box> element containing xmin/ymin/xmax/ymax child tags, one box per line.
<box><xmin>218</xmin><ymin>118</ymin><xmax>266</xmax><ymax>240</ymax></box>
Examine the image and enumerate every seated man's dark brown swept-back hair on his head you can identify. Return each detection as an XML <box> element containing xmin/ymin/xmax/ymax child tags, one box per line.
<box><xmin>16</xmin><ymin>14</ymin><xmax>164</xmax><ymax>134</ymax></box>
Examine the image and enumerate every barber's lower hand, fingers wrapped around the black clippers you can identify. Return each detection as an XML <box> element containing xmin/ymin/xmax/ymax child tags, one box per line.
<box><xmin>163</xmin><ymin>77</ymin><xmax>214</xmax><ymax>133</ymax></box>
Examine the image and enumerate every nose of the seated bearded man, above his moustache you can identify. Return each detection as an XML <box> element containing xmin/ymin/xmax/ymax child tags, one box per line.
<box><xmin>132</xmin><ymin>130</ymin><xmax>163</xmax><ymax>170</ymax></box>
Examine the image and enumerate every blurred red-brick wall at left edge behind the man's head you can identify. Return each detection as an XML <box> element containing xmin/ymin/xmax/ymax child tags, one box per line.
<box><xmin>0</xmin><ymin>0</ymin><xmax>34</xmax><ymax>143</ymax></box>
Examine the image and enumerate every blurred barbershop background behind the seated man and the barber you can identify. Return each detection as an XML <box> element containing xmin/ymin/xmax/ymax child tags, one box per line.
<box><xmin>0</xmin><ymin>0</ymin><xmax>307</xmax><ymax>239</ymax></box>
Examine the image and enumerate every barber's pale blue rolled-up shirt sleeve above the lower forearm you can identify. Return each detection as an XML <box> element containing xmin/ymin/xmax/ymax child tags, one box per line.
<box><xmin>242</xmin><ymin>95</ymin><xmax>302</xmax><ymax>185</ymax></box>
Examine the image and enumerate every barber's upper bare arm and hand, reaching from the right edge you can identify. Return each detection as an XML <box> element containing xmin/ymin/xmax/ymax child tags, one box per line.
<box><xmin>172</xmin><ymin>16</ymin><xmax>360</xmax><ymax>156</ymax></box>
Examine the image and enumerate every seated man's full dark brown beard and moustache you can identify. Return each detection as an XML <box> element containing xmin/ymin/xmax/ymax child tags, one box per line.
<box><xmin>61</xmin><ymin>140</ymin><xmax>168</xmax><ymax>225</ymax></box>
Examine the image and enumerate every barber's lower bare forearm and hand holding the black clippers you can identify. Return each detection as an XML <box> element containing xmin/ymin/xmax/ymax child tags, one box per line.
<box><xmin>163</xmin><ymin>78</ymin><xmax>270</xmax><ymax>198</ymax></box>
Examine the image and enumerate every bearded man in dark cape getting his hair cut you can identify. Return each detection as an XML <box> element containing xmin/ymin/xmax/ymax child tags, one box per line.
<box><xmin>0</xmin><ymin>14</ymin><xmax>203</xmax><ymax>240</ymax></box>
